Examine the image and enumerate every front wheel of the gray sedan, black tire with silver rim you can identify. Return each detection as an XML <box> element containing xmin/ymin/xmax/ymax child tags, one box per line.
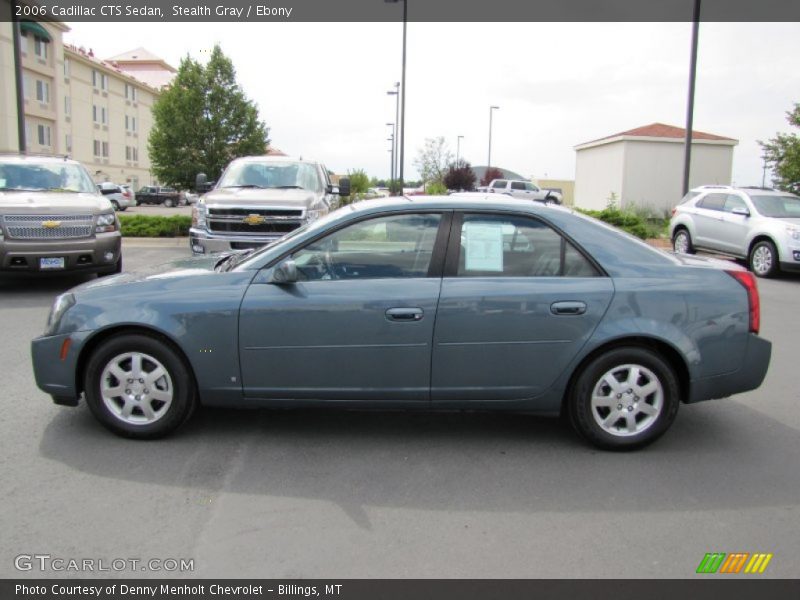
<box><xmin>84</xmin><ymin>333</ymin><xmax>197</xmax><ymax>439</ymax></box>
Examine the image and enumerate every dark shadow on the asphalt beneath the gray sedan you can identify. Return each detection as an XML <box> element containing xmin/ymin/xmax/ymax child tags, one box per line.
<box><xmin>40</xmin><ymin>401</ymin><xmax>800</xmax><ymax>528</ymax></box>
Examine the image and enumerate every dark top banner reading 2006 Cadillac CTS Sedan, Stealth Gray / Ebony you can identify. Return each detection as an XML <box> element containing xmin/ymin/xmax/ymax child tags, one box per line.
<box><xmin>0</xmin><ymin>0</ymin><xmax>800</xmax><ymax>23</ymax></box>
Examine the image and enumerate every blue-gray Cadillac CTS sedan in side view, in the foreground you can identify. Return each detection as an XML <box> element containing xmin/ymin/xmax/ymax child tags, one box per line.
<box><xmin>32</xmin><ymin>194</ymin><xmax>771</xmax><ymax>449</ymax></box>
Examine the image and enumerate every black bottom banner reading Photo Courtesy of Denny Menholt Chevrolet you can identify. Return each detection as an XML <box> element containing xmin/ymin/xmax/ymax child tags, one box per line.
<box><xmin>0</xmin><ymin>576</ymin><xmax>800</xmax><ymax>600</ymax></box>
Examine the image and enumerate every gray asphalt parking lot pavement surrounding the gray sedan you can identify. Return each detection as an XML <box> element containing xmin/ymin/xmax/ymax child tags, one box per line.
<box><xmin>0</xmin><ymin>246</ymin><xmax>800</xmax><ymax>578</ymax></box>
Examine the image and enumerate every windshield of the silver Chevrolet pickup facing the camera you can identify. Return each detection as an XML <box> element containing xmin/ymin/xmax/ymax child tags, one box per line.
<box><xmin>217</xmin><ymin>161</ymin><xmax>322</xmax><ymax>192</ymax></box>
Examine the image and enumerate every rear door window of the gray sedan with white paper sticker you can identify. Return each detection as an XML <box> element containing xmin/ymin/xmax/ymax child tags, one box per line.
<box><xmin>457</xmin><ymin>214</ymin><xmax>599</xmax><ymax>277</ymax></box>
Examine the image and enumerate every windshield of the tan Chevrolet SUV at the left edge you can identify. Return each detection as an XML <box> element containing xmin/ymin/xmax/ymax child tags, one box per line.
<box><xmin>0</xmin><ymin>160</ymin><xmax>97</xmax><ymax>194</ymax></box>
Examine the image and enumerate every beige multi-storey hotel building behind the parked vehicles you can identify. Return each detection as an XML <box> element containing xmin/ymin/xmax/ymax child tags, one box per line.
<box><xmin>0</xmin><ymin>21</ymin><xmax>176</xmax><ymax>190</ymax></box>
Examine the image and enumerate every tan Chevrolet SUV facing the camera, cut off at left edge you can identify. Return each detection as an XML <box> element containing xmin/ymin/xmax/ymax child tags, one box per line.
<box><xmin>0</xmin><ymin>155</ymin><xmax>122</xmax><ymax>275</ymax></box>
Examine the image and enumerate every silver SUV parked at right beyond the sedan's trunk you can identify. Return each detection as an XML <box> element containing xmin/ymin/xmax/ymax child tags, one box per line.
<box><xmin>670</xmin><ymin>185</ymin><xmax>800</xmax><ymax>277</ymax></box>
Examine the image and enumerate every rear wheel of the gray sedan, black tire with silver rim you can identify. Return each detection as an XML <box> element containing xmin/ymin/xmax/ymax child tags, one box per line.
<box><xmin>567</xmin><ymin>346</ymin><xmax>680</xmax><ymax>450</ymax></box>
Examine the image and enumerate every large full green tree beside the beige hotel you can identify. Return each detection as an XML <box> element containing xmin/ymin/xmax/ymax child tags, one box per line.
<box><xmin>148</xmin><ymin>46</ymin><xmax>269</xmax><ymax>189</ymax></box>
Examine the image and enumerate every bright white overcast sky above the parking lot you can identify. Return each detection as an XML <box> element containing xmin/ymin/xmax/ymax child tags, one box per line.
<box><xmin>67</xmin><ymin>23</ymin><xmax>800</xmax><ymax>184</ymax></box>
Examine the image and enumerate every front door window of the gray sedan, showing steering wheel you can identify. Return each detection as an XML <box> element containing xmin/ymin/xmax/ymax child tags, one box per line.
<box><xmin>292</xmin><ymin>214</ymin><xmax>442</xmax><ymax>281</ymax></box>
